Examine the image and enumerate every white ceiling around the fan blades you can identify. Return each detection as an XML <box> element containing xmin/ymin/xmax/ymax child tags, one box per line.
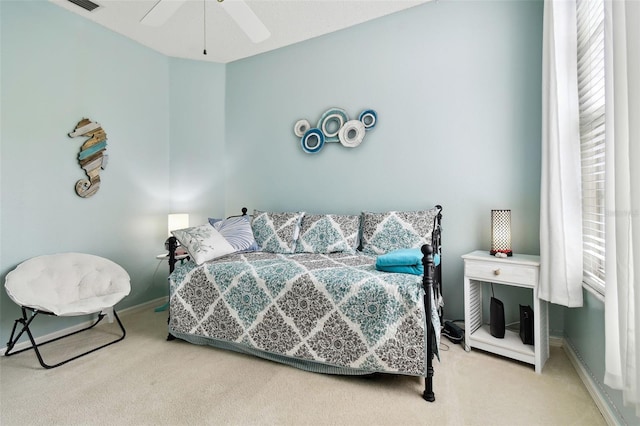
<box><xmin>49</xmin><ymin>0</ymin><xmax>430</xmax><ymax>63</ymax></box>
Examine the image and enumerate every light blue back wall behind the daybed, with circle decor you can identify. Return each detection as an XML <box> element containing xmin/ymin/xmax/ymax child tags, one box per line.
<box><xmin>226</xmin><ymin>1</ymin><xmax>544</xmax><ymax>329</ymax></box>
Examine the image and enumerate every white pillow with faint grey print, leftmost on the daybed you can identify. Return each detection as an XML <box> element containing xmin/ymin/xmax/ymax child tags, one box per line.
<box><xmin>171</xmin><ymin>223</ymin><xmax>236</xmax><ymax>265</ymax></box>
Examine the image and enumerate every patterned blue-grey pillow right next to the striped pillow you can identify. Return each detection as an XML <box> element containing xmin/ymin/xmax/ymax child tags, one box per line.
<box><xmin>251</xmin><ymin>210</ymin><xmax>304</xmax><ymax>254</ymax></box>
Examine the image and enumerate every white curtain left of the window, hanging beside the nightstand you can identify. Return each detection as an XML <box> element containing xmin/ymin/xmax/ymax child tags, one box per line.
<box><xmin>538</xmin><ymin>0</ymin><xmax>582</xmax><ymax>307</ymax></box>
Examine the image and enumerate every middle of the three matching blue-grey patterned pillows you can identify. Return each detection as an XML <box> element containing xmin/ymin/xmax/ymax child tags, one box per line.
<box><xmin>296</xmin><ymin>214</ymin><xmax>360</xmax><ymax>253</ymax></box>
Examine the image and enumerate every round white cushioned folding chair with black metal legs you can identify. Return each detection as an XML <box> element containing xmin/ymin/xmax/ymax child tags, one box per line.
<box><xmin>4</xmin><ymin>253</ymin><xmax>131</xmax><ymax>368</ymax></box>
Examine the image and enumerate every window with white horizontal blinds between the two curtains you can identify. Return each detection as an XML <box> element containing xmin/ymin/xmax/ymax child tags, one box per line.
<box><xmin>576</xmin><ymin>0</ymin><xmax>605</xmax><ymax>294</ymax></box>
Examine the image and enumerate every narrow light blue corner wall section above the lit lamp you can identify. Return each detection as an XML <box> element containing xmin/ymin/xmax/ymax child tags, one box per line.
<box><xmin>169</xmin><ymin>59</ymin><xmax>226</xmax><ymax>225</ymax></box>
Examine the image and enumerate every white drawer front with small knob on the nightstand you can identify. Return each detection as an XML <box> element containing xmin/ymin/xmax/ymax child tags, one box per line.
<box><xmin>464</xmin><ymin>260</ymin><xmax>538</xmax><ymax>287</ymax></box>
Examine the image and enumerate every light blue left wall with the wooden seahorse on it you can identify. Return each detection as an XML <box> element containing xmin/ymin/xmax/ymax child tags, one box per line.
<box><xmin>0</xmin><ymin>1</ymin><xmax>170</xmax><ymax>343</ymax></box>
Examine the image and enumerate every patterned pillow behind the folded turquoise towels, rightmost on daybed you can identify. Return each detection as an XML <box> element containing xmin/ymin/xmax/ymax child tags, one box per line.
<box><xmin>362</xmin><ymin>207</ymin><xmax>438</xmax><ymax>255</ymax></box>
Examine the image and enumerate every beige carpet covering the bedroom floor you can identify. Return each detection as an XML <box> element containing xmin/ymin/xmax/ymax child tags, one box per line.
<box><xmin>0</xmin><ymin>308</ymin><xmax>605</xmax><ymax>426</ymax></box>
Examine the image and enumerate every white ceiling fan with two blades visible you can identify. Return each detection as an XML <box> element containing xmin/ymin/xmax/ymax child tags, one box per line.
<box><xmin>140</xmin><ymin>0</ymin><xmax>271</xmax><ymax>43</ymax></box>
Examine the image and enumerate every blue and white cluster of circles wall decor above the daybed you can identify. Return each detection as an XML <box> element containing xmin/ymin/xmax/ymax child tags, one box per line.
<box><xmin>293</xmin><ymin>108</ymin><xmax>378</xmax><ymax>154</ymax></box>
